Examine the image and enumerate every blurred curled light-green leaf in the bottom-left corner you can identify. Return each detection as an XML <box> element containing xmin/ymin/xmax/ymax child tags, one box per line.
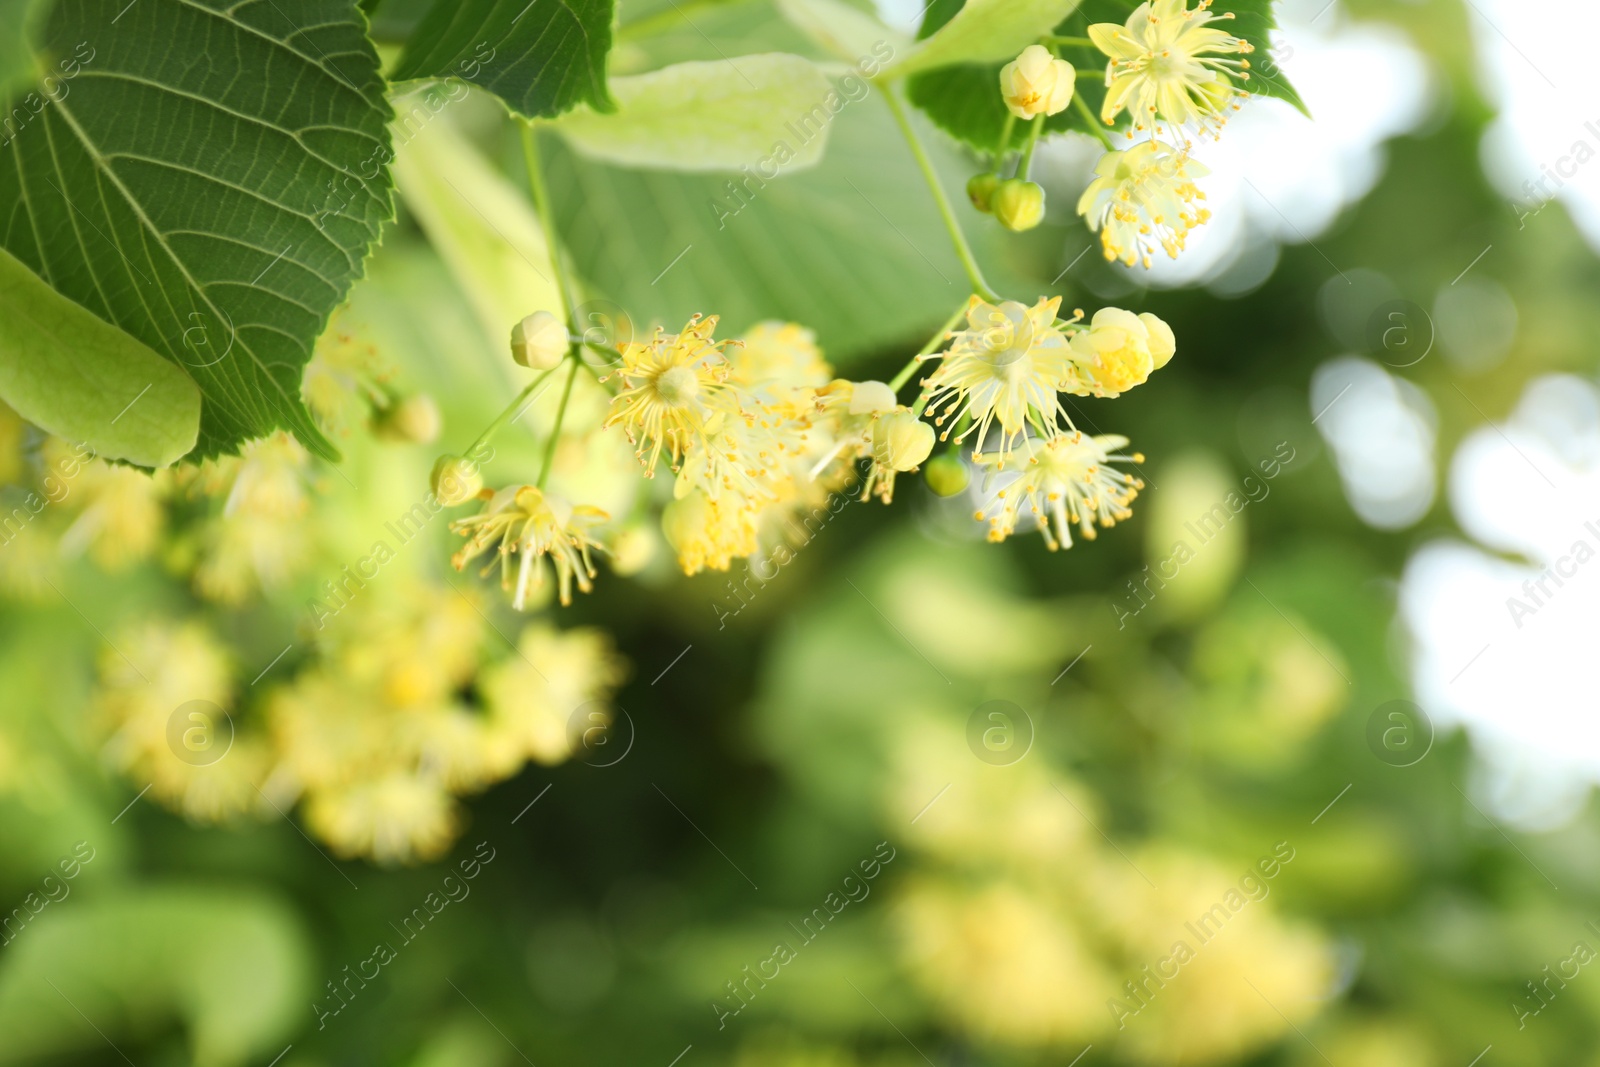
<box><xmin>0</xmin><ymin>883</ymin><xmax>317</xmax><ymax>1067</ymax></box>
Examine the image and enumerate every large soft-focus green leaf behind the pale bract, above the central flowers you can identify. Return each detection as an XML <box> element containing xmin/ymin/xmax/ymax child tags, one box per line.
<box><xmin>549</xmin><ymin>98</ymin><xmax>1030</xmax><ymax>365</ymax></box>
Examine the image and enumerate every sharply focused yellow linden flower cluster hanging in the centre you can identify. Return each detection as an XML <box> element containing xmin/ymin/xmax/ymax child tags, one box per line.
<box><xmin>435</xmin><ymin>296</ymin><xmax>1176</xmax><ymax>591</ymax></box>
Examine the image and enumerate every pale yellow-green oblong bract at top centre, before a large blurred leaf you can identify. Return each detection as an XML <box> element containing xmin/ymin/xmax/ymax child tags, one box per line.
<box><xmin>555</xmin><ymin>53</ymin><xmax>845</xmax><ymax>171</ymax></box>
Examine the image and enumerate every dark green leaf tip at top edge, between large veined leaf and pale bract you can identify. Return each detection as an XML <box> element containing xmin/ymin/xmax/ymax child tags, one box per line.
<box><xmin>394</xmin><ymin>0</ymin><xmax>616</xmax><ymax>118</ymax></box>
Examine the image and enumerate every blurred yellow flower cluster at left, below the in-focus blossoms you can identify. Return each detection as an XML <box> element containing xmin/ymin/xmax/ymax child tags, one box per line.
<box><xmin>94</xmin><ymin>581</ymin><xmax>624</xmax><ymax>864</ymax></box>
